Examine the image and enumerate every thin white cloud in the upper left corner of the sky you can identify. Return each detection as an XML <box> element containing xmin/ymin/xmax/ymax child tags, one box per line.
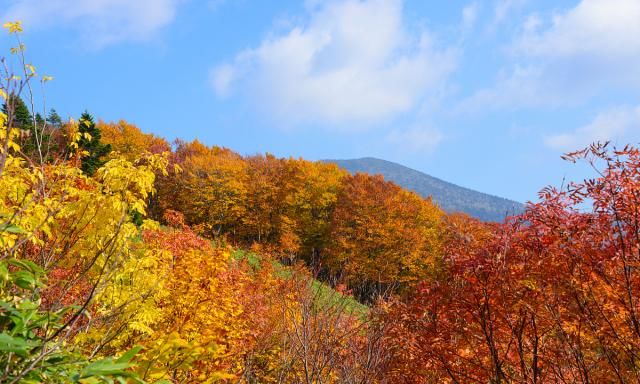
<box><xmin>0</xmin><ymin>0</ymin><xmax>181</xmax><ymax>48</ymax></box>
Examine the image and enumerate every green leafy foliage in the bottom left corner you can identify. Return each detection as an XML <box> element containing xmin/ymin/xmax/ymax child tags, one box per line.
<box><xmin>0</xmin><ymin>255</ymin><xmax>142</xmax><ymax>383</ymax></box>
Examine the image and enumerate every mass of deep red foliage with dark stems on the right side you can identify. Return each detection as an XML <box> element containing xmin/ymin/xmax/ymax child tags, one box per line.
<box><xmin>388</xmin><ymin>145</ymin><xmax>640</xmax><ymax>383</ymax></box>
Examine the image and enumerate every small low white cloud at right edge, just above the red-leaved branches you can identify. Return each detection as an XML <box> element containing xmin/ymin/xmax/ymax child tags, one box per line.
<box><xmin>544</xmin><ymin>106</ymin><xmax>640</xmax><ymax>150</ymax></box>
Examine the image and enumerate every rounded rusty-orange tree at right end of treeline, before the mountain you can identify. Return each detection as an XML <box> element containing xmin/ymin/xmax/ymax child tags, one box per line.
<box><xmin>325</xmin><ymin>173</ymin><xmax>442</xmax><ymax>301</ymax></box>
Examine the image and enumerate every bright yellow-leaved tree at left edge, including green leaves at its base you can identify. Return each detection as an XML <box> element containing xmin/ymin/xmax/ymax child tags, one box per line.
<box><xmin>0</xmin><ymin>22</ymin><xmax>167</xmax><ymax>383</ymax></box>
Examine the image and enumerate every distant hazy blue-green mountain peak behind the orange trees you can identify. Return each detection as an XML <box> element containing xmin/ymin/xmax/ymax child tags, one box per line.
<box><xmin>323</xmin><ymin>157</ymin><xmax>524</xmax><ymax>221</ymax></box>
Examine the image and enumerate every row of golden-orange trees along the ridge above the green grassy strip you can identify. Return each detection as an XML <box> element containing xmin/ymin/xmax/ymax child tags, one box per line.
<box><xmin>84</xmin><ymin>121</ymin><xmax>443</xmax><ymax>303</ymax></box>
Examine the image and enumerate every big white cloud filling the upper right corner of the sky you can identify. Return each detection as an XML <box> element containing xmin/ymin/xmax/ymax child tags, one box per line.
<box><xmin>463</xmin><ymin>0</ymin><xmax>640</xmax><ymax>109</ymax></box>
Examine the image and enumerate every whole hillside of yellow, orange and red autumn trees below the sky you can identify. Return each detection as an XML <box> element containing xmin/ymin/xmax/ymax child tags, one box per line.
<box><xmin>0</xmin><ymin>23</ymin><xmax>640</xmax><ymax>384</ymax></box>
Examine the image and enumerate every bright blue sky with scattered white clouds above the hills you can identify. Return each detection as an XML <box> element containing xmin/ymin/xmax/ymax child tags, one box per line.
<box><xmin>0</xmin><ymin>0</ymin><xmax>640</xmax><ymax>201</ymax></box>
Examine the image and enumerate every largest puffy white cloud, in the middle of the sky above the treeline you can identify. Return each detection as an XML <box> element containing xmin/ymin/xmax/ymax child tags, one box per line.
<box><xmin>211</xmin><ymin>0</ymin><xmax>456</xmax><ymax>127</ymax></box>
